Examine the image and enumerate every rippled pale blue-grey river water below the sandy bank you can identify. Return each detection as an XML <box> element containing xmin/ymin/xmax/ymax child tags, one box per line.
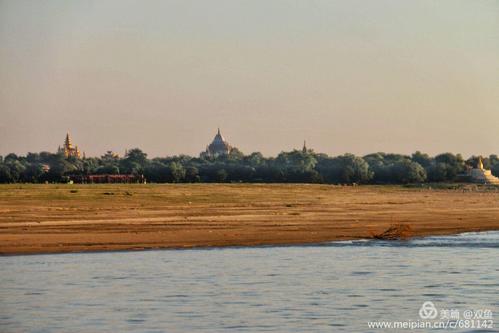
<box><xmin>0</xmin><ymin>232</ymin><xmax>499</xmax><ymax>332</ymax></box>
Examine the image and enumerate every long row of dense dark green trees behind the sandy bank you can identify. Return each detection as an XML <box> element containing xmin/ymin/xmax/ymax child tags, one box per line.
<box><xmin>0</xmin><ymin>148</ymin><xmax>499</xmax><ymax>184</ymax></box>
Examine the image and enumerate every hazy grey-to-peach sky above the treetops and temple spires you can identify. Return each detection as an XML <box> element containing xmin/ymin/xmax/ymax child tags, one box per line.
<box><xmin>0</xmin><ymin>0</ymin><xmax>499</xmax><ymax>157</ymax></box>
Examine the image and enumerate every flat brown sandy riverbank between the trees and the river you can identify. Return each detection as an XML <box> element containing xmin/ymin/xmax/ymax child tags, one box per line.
<box><xmin>0</xmin><ymin>184</ymin><xmax>499</xmax><ymax>254</ymax></box>
